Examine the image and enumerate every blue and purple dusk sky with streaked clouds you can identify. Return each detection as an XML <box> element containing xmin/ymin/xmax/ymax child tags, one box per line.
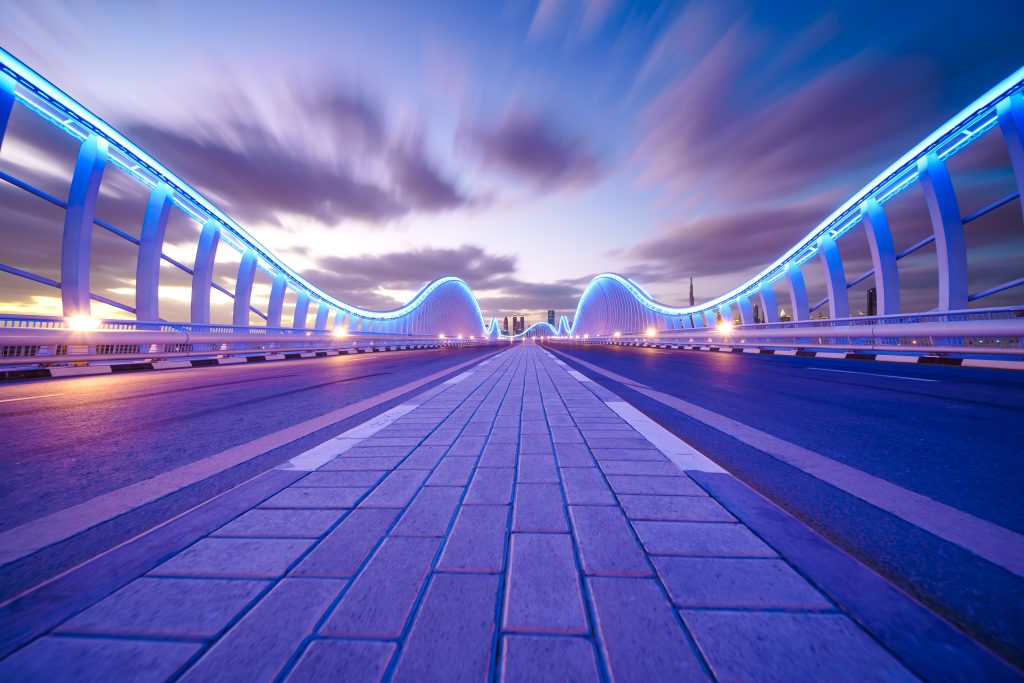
<box><xmin>0</xmin><ymin>0</ymin><xmax>1024</xmax><ymax>321</ymax></box>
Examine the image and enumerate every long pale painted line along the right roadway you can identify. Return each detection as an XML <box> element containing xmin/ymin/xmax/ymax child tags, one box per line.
<box><xmin>557</xmin><ymin>350</ymin><xmax>1024</xmax><ymax>577</ymax></box>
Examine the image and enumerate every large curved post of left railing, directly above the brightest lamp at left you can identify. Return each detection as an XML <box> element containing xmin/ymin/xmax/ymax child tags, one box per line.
<box><xmin>60</xmin><ymin>134</ymin><xmax>106</xmax><ymax>315</ymax></box>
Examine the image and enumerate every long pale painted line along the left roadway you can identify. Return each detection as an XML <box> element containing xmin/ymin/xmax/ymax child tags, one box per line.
<box><xmin>0</xmin><ymin>349</ymin><xmax>504</xmax><ymax>567</ymax></box>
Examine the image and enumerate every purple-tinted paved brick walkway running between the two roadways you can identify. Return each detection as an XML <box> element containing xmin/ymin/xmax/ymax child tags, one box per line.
<box><xmin>0</xmin><ymin>345</ymin><xmax>913</xmax><ymax>682</ymax></box>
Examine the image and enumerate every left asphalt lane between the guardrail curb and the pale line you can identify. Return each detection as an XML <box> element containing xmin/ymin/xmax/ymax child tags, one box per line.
<box><xmin>0</xmin><ymin>347</ymin><xmax>494</xmax><ymax>531</ymax></box>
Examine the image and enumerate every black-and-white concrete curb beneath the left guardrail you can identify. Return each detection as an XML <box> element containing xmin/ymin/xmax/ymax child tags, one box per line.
<box><xmin>0</xmin><ymin>344</ymin><xmax>441</xmax><ymax>382</ymax></box>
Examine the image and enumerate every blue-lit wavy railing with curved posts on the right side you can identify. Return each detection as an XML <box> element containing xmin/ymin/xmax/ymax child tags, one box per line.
<box><xmin>523</xmin><ymin>63</ymin><xmax>1024</xmax><ymax>337</ymax></box>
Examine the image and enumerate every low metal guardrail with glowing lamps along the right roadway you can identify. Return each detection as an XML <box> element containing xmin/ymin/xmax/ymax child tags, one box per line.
<box><xmin>546</xmin><ymin>306</ymin><xmax>1024</xmax><ymax>356</ymax></box>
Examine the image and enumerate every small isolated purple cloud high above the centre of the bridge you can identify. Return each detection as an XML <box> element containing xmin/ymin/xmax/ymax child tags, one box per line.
<box><xmin>461</xmin><ymin>112</ymin><xmax>603</xmax><ymax>191</ymax></box>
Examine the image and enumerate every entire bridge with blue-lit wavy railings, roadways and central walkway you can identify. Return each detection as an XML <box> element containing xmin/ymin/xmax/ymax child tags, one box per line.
<box><xmin>0</xmin><ymin>45</ymin><xmax>1024</xmax><ymax>681</ymax></box>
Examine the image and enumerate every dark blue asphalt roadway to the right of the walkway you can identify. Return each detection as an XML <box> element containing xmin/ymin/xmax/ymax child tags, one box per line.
<box><xmin>550</xmin><ymin>344</ymin><xmax>1024</xmax><ymax>661</ymax></box>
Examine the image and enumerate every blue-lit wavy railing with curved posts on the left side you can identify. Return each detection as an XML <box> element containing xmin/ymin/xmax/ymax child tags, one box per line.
<box><xmin>0</xmin><ymin>49</ymin><xmax>498</xmax><ymax>337</ymax></box>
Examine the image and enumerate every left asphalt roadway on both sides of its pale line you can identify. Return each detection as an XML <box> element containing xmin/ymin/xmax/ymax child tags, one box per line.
<box><xmin>0</xmin><ymin>347</ymin><xmax>496</xmax><ymax>602</ymax></box>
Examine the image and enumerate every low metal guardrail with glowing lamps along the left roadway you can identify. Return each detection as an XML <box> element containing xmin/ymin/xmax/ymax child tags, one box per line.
<box><xmin>0</xmin><ymin>315</ymin><xmax>495</xmax><ymax>367</ymax></box>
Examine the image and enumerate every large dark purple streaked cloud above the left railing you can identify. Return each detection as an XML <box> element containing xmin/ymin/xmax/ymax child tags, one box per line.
<box><xmin>125</xmin><ymin>84</ymin><xmax>471</xmax><ymax>224</ymax></box>
